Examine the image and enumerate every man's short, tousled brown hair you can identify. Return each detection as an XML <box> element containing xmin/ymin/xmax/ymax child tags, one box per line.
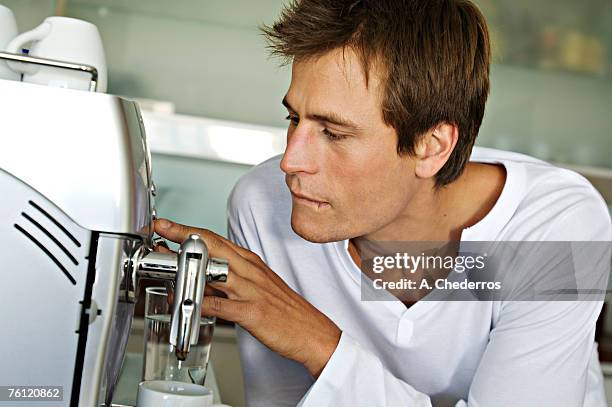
<box><xmin>262</xmin><ymin>0</ymin><xmax>491</xmax><ymax>186</ymax></box>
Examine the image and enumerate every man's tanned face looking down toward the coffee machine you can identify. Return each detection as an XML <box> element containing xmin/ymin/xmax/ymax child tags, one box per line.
<box><xmin>281</xmin><ymin>49</ymin><xmax>416</xmax><ymax>243</ymax></box>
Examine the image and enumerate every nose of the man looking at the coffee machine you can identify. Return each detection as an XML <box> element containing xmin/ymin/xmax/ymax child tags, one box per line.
<box><xmin>280</xmin><ymin>123</ymin><xmax>318</xmax><ymax>174</ymax></box>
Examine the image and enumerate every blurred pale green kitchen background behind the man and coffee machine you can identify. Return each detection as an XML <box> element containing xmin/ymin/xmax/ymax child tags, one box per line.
<box><xmin>0</xmin><ymin>0</ymin><xmax>612</xmax><ymax>407</ymax></box>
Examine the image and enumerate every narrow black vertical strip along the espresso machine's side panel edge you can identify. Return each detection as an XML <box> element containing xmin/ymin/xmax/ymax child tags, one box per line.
<box><xmin>70</xmin><ymin>232</ymin><xmax>100</xmax><ymax>407</ymax></box>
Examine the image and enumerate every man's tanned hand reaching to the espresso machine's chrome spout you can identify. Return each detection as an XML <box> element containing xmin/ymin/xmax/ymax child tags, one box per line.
<box><xmin>155</xmin><ymin>219</ymin><xmax>341</xmax><ymax>378</ymax></box>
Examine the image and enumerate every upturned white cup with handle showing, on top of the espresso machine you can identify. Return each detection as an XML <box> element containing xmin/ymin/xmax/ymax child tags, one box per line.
<box><xmin>6</xmin><ymin>17</ymin><xmax>107</xmax><ymax>92</ymax></box>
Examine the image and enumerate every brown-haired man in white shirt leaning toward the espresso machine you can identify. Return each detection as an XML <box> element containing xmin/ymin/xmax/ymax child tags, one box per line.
<box><xmin>155</xmin><ymin>0</ymin><xmax>612</xmax><ymax>407</ymax></box>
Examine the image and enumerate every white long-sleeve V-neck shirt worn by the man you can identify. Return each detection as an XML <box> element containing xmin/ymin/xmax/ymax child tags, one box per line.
<box><xmin>228</xmin><ymin>148</ymin><xmax>612</xmax><ymax>407</ymax></box>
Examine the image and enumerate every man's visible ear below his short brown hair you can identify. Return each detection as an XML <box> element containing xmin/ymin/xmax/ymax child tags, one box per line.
<box><xmin>414</xmin><ymin>123</ymin><xmax>459</xmax><ymax>179</ymax></box>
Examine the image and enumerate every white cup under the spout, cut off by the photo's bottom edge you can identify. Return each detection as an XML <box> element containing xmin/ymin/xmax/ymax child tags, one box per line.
<box><xmin>136</xmin><ymin>380</ymin><xmax>213</xmax><ymax>407</ymax></box>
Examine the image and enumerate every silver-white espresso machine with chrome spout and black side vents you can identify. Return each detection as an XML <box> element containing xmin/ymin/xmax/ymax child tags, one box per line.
<box><xmin>0</xmin><ymin>53</ymin><xmax>228</xmax><ymax>406</ymax></box>
